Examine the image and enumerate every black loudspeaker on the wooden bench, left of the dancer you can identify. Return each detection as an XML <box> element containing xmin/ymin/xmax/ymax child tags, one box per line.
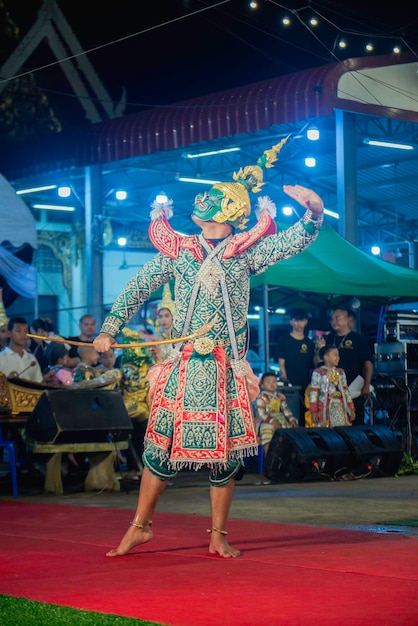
<box><xmin>26</xmin><ymin>389</ymin><xmax>132</xmax><ymax>444</ymax></box>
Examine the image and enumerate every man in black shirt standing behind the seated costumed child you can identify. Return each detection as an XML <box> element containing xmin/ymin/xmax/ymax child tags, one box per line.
<box><xmin>278</xmin><ymin>309</ymin><xmax>315</xmax><ymax>426</ymax></box>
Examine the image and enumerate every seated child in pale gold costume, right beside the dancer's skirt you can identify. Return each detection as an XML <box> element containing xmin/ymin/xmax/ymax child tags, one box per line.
<box><xmin>255</xmin><ymin>372</ymin><xmax>298</xmax><ymax>455</ymax></box>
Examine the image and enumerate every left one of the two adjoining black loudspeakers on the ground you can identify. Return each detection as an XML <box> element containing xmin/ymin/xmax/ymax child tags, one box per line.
<box><xmin>264</xmin><ymin>428</ymin><xmax>350</xmax><ymax>482</ymax></box>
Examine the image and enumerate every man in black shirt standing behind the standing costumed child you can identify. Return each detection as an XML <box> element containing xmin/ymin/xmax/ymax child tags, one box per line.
<box><xmin>325</xmin><ymin>308</ymin><xmax>374</xmax><ymax>425</ymax></box>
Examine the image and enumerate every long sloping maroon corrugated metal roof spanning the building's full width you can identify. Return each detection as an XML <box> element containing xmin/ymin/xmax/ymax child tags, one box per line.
<box><xmin>2</xmin><ymin>55</ymin><xmax>416</xmax><ymax>178</ymax></box>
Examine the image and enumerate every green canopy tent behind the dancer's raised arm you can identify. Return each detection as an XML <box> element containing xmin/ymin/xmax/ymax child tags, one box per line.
<box><xmin>251</xmin><ymin>224</ymin><xmax>418</xmax><ymax>369</ymax></box>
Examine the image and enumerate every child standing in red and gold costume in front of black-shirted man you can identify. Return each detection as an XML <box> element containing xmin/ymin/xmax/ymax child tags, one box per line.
<box><xmin>305</xmin><ymin>345</ymin><xmax>356</xmax><ymax>428</ymax></box>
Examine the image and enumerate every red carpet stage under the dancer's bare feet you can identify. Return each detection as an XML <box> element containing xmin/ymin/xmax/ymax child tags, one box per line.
<box><xmin>0</xmin><ymin>500</ymin><xmax>418</xmax><ymax>626</ymax></box>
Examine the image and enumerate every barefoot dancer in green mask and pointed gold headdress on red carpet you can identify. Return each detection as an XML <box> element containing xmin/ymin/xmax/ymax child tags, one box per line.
<box><xmin>94</xmin><ymin>140</ymin><xmax>323</xmax><ymax>558</ymax></box>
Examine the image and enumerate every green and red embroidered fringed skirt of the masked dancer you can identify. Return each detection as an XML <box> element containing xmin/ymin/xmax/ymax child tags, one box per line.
<box><xmin>146</xmin><ymin>344</ymin><xmax>258</xmax><ymax>469</ymax></box>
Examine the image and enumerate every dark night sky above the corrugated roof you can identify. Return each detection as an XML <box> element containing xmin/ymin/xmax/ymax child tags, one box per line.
<box><xmin>5</xmin><ymin>0</ymin><xmax>418</xmax><ymax>133</ymax></box>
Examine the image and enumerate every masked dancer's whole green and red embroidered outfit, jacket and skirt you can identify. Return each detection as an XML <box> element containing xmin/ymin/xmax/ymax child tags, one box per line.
<box><xmin>101</xmin><ymin>212</ymin><xmax>322</xmax><ymax>469</ymax></box>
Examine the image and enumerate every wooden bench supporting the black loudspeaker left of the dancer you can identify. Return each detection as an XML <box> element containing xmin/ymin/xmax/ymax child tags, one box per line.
<box><xmin>29</xmin><ymin>441</ymin><xmax>129</xmax><ymax>496</ymax></box>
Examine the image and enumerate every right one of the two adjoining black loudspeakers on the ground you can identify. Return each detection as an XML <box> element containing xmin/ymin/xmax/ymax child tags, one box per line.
<box><xmin>334</xmin><ymin>425</ymin><xmax>403</xmax><ymax>476</ymax></box>
